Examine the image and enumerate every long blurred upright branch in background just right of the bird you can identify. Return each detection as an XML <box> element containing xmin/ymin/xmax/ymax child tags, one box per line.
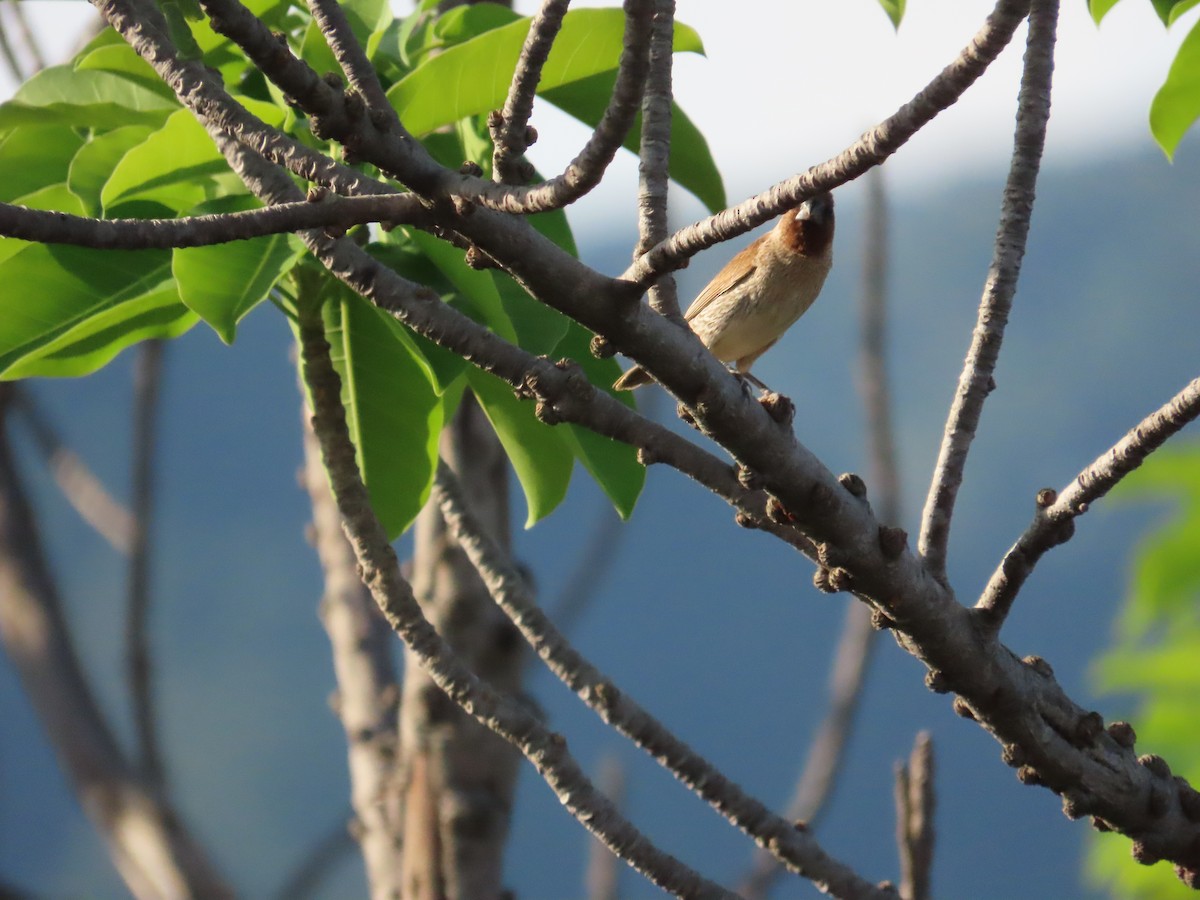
<box><xmin>739</xmin><ymin>168</ymin><xmax>900</xmax><ymax>900</ymax></box>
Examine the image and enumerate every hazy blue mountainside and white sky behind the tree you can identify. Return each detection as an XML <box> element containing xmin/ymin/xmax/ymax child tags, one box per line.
<box><xmin>0</xmin><ymin>0</ymin><xmax>1200</xmax><ymax>900</ymax></box>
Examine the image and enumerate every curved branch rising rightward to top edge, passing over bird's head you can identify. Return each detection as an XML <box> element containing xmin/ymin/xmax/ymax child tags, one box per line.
<box><xmin>622</xmin><ymin>0</ymin><xmax>1030</xmax><ymax>288</ymax></box>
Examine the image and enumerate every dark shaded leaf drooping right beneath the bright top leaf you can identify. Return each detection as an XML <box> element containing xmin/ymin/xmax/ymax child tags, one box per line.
<box><xmin>545</xmin><ymin>72</ymin><xmax>726</xmax><ymax>212</ymax></box>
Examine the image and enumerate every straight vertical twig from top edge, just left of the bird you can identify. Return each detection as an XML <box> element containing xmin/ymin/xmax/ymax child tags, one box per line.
<box><xmin>634</xmin><ymin>0</ymin><xmax>683</xmax><ymax>322</ymax></box>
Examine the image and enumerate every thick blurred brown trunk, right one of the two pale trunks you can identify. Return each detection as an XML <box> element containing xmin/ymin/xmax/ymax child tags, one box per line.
<box><xmin>400</xmin><ymin>394</ymin><xmax>522</xmax><ymax>900</ymax></box>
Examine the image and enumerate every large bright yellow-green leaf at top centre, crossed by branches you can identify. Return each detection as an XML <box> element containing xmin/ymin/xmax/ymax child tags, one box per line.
<box><xmin>388</xmin><ymin>10</ymin><xmax>702</xmax><ymax>134</ymax></box>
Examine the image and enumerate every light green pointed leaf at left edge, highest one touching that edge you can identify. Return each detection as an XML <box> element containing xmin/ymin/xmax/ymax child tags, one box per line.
<box><xmin>0</xmin><ymin>65</ymin><xmax>179</xmax><ymax>131</ymax></box>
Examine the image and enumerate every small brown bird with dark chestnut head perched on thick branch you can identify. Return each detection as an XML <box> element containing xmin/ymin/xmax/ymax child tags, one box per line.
<box><xmin>613</xmin><ymin>193</ymin><xmax>833</xmax><ymax>390</ymax></box>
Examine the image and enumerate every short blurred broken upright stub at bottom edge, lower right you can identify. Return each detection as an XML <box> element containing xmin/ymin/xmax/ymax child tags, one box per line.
<box><xmin>895</xmin><ymin>731</ymin><xmax>936</xmax><ymax>900</ymax></box>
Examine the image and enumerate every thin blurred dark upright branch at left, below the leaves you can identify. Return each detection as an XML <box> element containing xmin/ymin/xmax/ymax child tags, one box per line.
<box><xmin>125</xmin><ymin>341</ymin><xmax>164</xmax><ymax>791</ymax></box>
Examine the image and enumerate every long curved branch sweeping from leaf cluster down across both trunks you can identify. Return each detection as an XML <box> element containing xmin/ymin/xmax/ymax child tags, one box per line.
<box><xmin>300</xmin><ymin>311</ymin><xmax>732</xmax><ymax>898</ymax></box>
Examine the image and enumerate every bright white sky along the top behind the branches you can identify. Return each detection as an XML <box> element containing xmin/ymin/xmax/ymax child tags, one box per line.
<box><xmin>5</xmin><ymin>0</ymin><xmax>1195</xmax><ymax>229</ymax></box>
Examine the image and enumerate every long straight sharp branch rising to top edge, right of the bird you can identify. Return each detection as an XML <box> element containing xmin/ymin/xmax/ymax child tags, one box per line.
<box><xmin>918</xmin><ymin>0</ymin><xmax>1058</xmax><ymax>578</ymax></box>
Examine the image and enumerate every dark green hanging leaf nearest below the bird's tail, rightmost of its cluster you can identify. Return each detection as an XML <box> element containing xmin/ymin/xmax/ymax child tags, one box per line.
<box><xmin>554</xmin><ymin>322</ymin><xmax>646</xmax><ymax>518</ymax></box>
